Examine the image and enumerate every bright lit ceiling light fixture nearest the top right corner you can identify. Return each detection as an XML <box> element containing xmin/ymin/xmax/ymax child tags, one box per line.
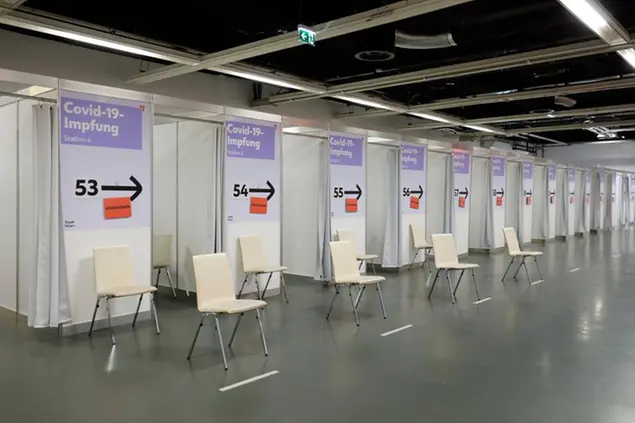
<box><xmin>558</xmin><ymin>0</ymin><xmax>628</xmax><ymax>46</ymax></box>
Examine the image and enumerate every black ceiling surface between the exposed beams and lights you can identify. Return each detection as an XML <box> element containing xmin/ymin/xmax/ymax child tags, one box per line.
<box><xmin>8</xmin><ymin>0</ymin><xmax>635</xmax><ymax>144</ymax></box>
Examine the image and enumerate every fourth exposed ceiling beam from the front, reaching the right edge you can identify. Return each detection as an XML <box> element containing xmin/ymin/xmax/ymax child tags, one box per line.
<box><xmin>402</xmin><ymin>103</ymin><xmax>635</xmax><ymax>131</ymax></box>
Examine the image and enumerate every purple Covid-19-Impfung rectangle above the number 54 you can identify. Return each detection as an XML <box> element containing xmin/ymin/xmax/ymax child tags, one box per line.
<box><xmin>225</xmin><ymin>120</ymin><xmax>278</xmax><ymax>160</ymax></box>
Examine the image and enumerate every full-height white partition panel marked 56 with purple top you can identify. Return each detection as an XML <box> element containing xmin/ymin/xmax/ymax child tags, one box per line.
<box><xmin>398</xmin><ymin>144</ymin><xmax>428</xmax><ymax>266</ymax></box>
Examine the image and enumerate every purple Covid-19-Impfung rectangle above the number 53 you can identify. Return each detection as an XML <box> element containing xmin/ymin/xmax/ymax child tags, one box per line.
<box><xmin>60</xmin><ymin>92</ymin><xmax>145</xmax><ymax>150</ymax></box>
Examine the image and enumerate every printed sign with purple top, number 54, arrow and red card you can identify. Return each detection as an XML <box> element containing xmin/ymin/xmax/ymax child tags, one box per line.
<box><xmin>225</xmin><ymin>118</ymin><xmax>281</xmax><ymax>222</ymax></box>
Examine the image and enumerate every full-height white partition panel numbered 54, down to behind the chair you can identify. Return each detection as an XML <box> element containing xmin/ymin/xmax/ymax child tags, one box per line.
<box><xmin>222</xmin><ymin>117</ymin><xmax>282</xmax><ymax>293</ymax></box>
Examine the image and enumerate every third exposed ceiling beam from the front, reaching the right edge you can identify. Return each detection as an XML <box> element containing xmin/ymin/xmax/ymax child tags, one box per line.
<box><xmin>337</xmin><ymin>77</ymin><xmax>635</xmax><ymax>119</ymax></box>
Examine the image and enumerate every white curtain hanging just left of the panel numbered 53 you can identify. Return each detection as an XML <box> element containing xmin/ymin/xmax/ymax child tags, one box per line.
<box><xmin>28</xmin><ymin>105</ymin><xmax>71</xmax><ymax>328</ymax></box>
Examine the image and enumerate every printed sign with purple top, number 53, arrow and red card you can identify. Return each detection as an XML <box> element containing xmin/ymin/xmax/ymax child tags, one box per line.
<box><xmin>59</xmin><ymin>90</ymin><xmax>152</xmax><ymax>230</ymax></box>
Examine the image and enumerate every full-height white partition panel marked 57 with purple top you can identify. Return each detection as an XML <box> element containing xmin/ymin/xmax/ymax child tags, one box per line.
<box><xmin>452</xmin><ymin>150</ymin><xmax>472</xmax><ymax>255</ymax></box>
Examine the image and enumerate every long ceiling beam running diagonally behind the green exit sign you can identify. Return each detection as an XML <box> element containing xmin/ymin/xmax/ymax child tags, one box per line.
<box><xmin>128</xmin><ymin>0</ymin><xmax>473</xmax><ymax>84</ymax></box>
